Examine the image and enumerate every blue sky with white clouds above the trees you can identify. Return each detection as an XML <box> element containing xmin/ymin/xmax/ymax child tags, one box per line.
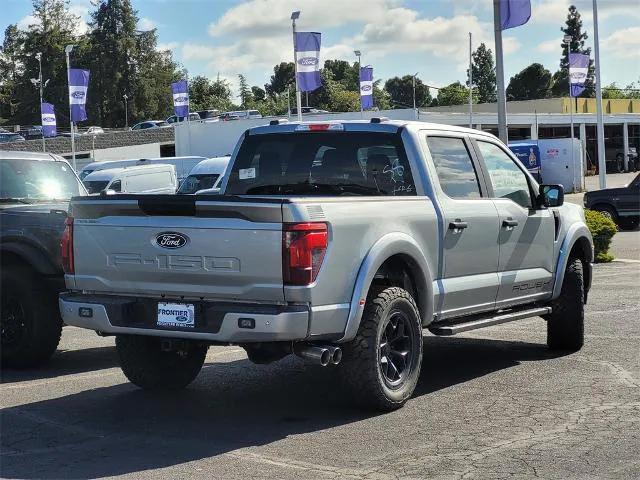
<box><xmin>0</xmin><ymin>0</ymin><xmax>640</xmax><ymax>98</ymax></box>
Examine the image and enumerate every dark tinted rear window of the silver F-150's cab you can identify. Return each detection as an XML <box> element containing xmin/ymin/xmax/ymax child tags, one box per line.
<box><xmin>225</xmin><ymin>132</ymin><xmax>416</xmax><ymax>196</ymax></box>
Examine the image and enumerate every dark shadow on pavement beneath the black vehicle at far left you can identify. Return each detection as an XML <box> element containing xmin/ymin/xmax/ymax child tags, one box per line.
<box><xmin>0</xmin><ymin>346</ymin><xmax>119</xmax><ymax>384</ymax></box>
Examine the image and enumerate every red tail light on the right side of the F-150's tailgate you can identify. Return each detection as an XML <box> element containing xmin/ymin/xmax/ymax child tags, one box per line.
<box><xmin>282</xmin><ymin>223</ymin><xmax>328</xmax><ymax>285</ymax></box>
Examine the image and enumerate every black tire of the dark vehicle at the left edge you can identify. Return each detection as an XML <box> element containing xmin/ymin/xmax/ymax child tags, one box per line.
<box><xmin>0</xmin><ymin>266</ymin><xmax>62</xmax><ymax>368</ymax></box>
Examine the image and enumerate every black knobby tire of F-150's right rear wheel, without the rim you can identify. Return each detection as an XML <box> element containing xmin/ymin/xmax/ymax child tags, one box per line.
<box><xmin>339</xmin><ymin>287</ymin><xmax>422</xmax><ymax>411</ymax></box>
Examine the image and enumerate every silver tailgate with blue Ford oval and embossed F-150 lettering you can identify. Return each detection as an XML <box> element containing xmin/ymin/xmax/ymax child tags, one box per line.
<box><xmin>69</xmin><ymin>195</ymin><xmax>284</xmax><ymax>302</ymax></box>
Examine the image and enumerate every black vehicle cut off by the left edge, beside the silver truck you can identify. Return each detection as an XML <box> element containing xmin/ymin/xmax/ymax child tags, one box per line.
<box><xmin>0</xmin><ymin>151</ymin><xmax>86</xmax><ymax>368</ymax></box>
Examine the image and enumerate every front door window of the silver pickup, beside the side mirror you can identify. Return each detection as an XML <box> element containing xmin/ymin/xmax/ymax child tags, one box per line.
<box><xmin>478</xmin><ymin>141</ymin><xmax>532</xmax><ymax>208</ymax></box>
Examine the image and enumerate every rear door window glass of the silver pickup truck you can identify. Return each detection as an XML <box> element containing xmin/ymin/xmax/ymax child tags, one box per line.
<box><xmin>427</xmin><ymin>137</ymin><xmax>481</xmax><ymax>198</ymax></box>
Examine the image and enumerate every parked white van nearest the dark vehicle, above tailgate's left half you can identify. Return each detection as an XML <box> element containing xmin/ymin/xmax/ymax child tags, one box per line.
<box><xmin>82</xmin><ymin>165</ymin><xmax>178</xmax><ymax>194</ymax></box>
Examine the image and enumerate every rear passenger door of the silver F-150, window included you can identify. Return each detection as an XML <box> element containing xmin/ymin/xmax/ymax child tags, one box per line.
<box><xmin>427</xmin><ymin>133</ymin><xmax>499</xmax><ymax>319</ymax></box>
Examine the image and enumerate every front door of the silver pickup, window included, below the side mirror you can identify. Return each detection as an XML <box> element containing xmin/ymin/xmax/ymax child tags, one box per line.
<box><xmin>475</xmin><ymin>140</ymin><xmax>555</xmax><ymax>308</ymax></box>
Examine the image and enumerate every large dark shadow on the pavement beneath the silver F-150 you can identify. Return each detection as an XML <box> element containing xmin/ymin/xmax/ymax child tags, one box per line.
<box><xmin>0</xmin><ymin>337</ymin><xmax>568</xmax><ymax>479</ymax></box>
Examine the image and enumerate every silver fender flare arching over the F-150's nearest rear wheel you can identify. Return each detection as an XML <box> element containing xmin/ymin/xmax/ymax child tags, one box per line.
<box><xmin>338</xmin><ymin>232</ymin><xmax>433</xmax><ymax>343</ymax></box>
